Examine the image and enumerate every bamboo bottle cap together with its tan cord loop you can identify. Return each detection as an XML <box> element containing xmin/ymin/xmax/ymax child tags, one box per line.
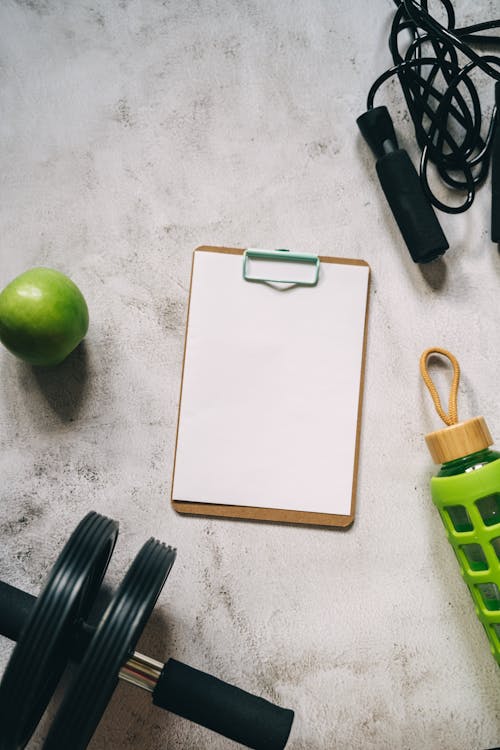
<box><xmin>420</xmin><ymin>347</ymin><xmax>493</xmax><ymax>464</ymax></box>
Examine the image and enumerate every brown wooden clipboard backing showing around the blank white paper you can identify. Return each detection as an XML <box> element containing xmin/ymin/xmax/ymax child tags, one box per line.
<box><xmin>171</xmin><ymin>246</ymin><xmax>370</xmax><ymax>527</ymax></box>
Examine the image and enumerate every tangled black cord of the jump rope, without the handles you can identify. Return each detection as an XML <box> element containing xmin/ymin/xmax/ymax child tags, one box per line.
<box><xmin>367</xmin><ymin>0</ymin><xmax>500</xmax><ymax>214</ymax></box>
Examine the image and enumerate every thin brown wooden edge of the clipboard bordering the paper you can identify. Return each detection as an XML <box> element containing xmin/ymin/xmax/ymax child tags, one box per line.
<box><xmin>170</xmin><ymin>245</ymin><xmax>371</xmax><ymax>528</ymax></box>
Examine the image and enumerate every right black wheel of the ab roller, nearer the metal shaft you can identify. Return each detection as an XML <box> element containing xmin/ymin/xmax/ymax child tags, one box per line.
<box><xmin>43</xmin><ymin>539</ymin><xmax>176</xmax><ymax>750</ymax></box>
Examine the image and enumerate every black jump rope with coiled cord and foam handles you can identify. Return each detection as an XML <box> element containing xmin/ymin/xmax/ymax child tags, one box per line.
<box><xmin>357</xmin><ymin>0</ymin><xmax>500</xmax><ymax>263</ymax></box>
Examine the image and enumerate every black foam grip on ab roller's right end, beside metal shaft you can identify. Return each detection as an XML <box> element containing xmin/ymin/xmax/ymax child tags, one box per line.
<box><xmin>153</xmin><ymin>659</ymin><xmax>294</xmax><ymax>750</ymax></box>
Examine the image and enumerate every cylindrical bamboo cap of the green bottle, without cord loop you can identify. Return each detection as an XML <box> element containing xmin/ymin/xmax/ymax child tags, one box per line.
<box><xmin>425</xmin><ymin>417</ymin><xmax>493</xmax><ymax>464</ymax></box>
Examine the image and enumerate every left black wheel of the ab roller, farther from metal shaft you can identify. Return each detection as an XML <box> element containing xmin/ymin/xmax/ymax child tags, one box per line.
<box><xmin>0</xmin><ymin>513</ymin><xmax>118</xmax><ymax>750</ymax></box>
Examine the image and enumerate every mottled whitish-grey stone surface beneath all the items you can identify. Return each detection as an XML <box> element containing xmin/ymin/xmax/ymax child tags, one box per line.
<box><xmin>0</xmin><ymin>0</ymin><xmax>500</xmax><ymax>750</ymax></box>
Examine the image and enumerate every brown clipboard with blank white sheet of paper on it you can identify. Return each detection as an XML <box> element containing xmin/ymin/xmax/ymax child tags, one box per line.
<box><xmin>171</xmin><ymin>246</ymin><xmax>370</xmax><ymax>527</ymax></box>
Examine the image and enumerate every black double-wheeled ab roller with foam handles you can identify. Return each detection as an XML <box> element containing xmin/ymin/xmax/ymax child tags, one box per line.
<box><xmin>0</xmin><ymin>513</ymin><xmax>293</xmax><ymax>750</ymax></box>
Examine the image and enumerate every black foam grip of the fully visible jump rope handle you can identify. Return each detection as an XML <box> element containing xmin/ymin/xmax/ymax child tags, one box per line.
<box><xmin>377</xmin><ymin>149</ymin><xmax>449</xmax><ymax>263</ymax></box>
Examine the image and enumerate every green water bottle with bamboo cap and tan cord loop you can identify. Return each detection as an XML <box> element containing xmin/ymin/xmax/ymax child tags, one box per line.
<box><xmin>420</xmin><ymin>348</ymin><xmax>500</xmax><ymax>664</ymax></box>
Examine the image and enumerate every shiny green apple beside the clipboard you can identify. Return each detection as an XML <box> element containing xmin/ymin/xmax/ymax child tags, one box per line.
<box><xmin>0</xmin><ymin>268</ymin><xmax>89</xmax><ymax>365</ymax></box>
